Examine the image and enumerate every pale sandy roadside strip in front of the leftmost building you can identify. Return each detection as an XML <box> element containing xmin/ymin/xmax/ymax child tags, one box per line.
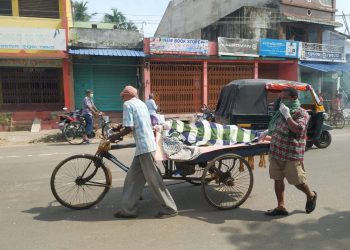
<box><xmin>0</xmin><ymin>129</ymin><xmax>64</xmax><ymax>146</ymax></box>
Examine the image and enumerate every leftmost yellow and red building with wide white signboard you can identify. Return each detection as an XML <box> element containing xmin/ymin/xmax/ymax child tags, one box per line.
<box><xmin>0</xmin><ymin>0</ymin><xmax>71</xmax><ymax>131</ymax></box>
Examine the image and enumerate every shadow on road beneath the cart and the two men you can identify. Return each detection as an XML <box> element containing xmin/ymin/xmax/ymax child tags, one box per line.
<box><xmin>23</xmin><ymin>181</ymin><xmax>320</xmax><ymax>224</ymax></box>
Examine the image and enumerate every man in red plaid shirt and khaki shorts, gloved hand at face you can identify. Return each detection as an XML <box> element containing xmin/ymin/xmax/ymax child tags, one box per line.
<box><xmin>260</xmin><ymin>88</ymin><xmax>317</xmax><ymax>216</ymax></box>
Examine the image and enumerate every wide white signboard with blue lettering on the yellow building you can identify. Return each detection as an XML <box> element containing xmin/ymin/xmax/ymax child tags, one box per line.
<box><xmin>0</xmin><ymin>28</ymin><xmax>67</xmax><ymax>51</ymax></box>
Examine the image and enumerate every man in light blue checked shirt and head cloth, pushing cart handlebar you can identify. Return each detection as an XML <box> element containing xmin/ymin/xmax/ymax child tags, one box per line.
<box><xmin>109</xmin><ymin>86</ymin><xmax>177</xmax><ymax>219</ymax></box>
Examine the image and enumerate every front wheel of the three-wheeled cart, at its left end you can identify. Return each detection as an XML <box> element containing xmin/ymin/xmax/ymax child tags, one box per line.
<box><xmin>50</xmin><ymin>155</ymin><xmax>112</xmax><ymax>209</ymax></box>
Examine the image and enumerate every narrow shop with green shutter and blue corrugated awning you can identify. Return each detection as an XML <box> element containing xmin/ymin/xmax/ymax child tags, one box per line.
<box><xmin>68</xmin><ymin>22</ymin><xmax>144</xmax><ymax>121</ymax></box>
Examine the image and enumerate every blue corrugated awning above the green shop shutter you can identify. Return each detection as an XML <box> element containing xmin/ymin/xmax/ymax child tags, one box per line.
<box><xmin>68</xmin><ymin>49</ymin><xmax>145</xmax><ymax>57</ymax></box>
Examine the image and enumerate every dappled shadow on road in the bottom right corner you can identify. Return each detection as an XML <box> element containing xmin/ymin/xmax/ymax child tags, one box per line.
<box><xmin>221</xmin><ymin>211</ymin><xmax>350</xmax><ymax>249</ymax></box>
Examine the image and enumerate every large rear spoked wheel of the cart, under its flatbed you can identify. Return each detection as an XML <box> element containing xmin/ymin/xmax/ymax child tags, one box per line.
<box><xmin>202</xmin><ymin>154</ymin><xmax>254</xmax><ymax>209</ymax></box>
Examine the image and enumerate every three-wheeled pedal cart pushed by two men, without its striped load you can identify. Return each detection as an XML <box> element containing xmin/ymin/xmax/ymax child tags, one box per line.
<box><xmin>51</xmin><ymin>134</ymin><xmax>269</xmax><ymax>209</ymax></box>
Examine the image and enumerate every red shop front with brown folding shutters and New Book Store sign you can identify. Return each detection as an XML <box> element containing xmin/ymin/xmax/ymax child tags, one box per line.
<box><xmin>143</xmin><ymin>38</ymin><xmax>298</xmax><ymax>118</ymax></box>
